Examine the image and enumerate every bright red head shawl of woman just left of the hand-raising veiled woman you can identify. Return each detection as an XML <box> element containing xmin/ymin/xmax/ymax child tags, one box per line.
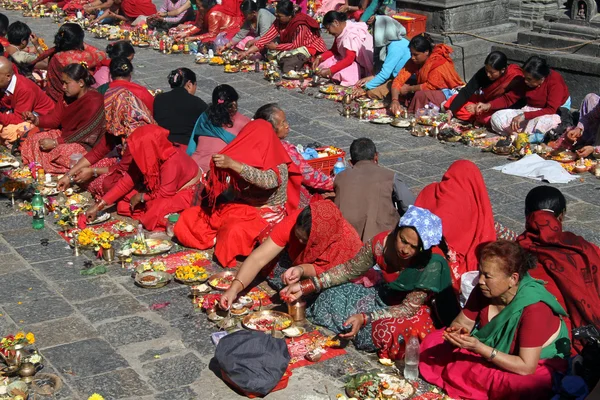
<box><xmin>127</xmin><ymin>125</ymin><xmax>177</xmax><ymax>192</ymax></box>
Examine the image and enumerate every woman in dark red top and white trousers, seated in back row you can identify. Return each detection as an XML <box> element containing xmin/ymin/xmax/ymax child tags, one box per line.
<box><xmin>488</xmin><ymin>56</ymin><xmax>571</xmax><ymax>134</ymax></box>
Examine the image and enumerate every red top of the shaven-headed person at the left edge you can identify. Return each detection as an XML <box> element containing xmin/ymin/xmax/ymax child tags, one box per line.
<box><xmin>0</xmin><ymin>74</ymin><xmax>54</xmax><ymax>125</ymax></box>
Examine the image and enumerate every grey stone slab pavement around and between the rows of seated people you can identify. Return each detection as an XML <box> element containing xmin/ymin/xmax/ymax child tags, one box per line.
<box><xmin>0</xmin><ymin>7</ymin><xmax>600</xmax><ymax>400</ymax></box>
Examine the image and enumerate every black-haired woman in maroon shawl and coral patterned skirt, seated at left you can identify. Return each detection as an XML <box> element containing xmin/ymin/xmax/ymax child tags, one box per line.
<box><xmin>21</xmin><ymin>64</ymin><xmax>106</xmax><ymax>174</ymax></box>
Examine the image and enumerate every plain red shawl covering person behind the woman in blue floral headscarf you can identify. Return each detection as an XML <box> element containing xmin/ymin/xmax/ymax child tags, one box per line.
<box><xmin>415</xmin><ymin>160</ymin><xmax>496</xmax><ymax>275</ymax></box>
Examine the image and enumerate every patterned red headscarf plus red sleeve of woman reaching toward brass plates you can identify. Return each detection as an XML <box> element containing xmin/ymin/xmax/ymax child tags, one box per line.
<box><xmin>271</xmin><ymin>200</ymin><xmax>362</xmax><ymax>274</ymax></box>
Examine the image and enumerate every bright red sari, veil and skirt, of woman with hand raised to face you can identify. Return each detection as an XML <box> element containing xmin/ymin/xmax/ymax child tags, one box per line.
<box><xmin>175</xmin><ymin>120</ymin><xmax>302</xmax><ymax>267</ymax></box>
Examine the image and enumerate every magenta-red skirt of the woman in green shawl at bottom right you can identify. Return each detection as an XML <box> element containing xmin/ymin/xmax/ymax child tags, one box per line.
<box><xmin>419</xmin><ymin>329</ymin><xmax>567</xmax><ymax>400</ymax></box>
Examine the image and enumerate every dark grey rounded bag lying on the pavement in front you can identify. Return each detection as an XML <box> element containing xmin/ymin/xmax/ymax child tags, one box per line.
<box><xmin>215</xmin><ymin>331</ymin><xmax>290</xmax><ymax>396</ymax></box>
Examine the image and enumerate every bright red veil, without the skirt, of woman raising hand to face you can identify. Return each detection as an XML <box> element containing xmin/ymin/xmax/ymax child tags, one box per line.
<box><xmin>207</xmin><ymin>119</ymin><xmax>302</xmax><ymax>213</ymax></box>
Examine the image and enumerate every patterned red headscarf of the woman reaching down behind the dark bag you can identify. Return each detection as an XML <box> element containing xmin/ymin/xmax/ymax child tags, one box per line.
<box><xmin>290</xmin><ymin>200</ymin><xmax>362</xmax><ymax>274</ymax></box>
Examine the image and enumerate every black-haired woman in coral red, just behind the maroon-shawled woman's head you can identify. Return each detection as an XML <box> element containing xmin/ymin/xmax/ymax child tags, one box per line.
<box><xmin>37</xmin><ymin>22</ymin><xmax>106</xmax><ymax>102</ymax></box>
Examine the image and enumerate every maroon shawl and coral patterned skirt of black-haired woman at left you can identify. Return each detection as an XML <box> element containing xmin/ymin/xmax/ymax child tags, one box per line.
<box><xmin>21</xmin><ymin>89</ymin><xmax>106</xmax><ymax>174</ymax></box>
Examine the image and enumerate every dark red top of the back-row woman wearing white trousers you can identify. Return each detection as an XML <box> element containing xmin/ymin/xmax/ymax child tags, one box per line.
<box><xmin>490</xmin><ymin>70</ymin><xmax>569</xmax><ymax>120</ymax></box>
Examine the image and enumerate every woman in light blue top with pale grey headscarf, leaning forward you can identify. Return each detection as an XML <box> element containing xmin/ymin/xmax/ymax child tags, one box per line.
<box><xmin>352</xmin><ymin>15</ymin><xmax>410</xmax><ymax>100</ymax></box>
